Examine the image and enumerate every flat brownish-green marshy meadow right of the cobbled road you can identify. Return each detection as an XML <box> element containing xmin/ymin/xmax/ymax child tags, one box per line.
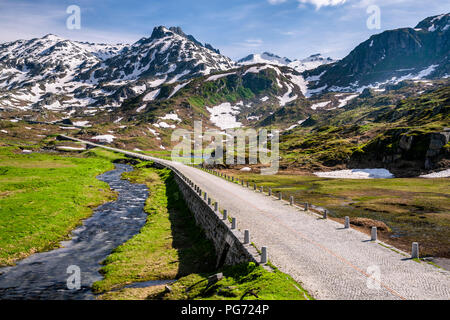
<box><xmin>228</xmin><ymin>172</ymin><xmax>450</xmax><ymax>258</ymax></box>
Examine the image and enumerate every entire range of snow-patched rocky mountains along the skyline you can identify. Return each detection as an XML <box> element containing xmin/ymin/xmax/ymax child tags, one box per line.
<box><xmin>0</xmin><ymin>14</ymin><xmax>450</xmax><ymax>120</ymax></box>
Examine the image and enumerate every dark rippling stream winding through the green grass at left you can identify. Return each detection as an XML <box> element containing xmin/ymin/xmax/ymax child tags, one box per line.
<box><xmin>0</xmin><ymin>164</ymin><xmax>148</xmax><ymax>300</ymax></box>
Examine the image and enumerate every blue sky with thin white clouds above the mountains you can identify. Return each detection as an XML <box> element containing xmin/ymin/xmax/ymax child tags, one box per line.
<box><xmin>0</xmin><ymin>0</ymin><xmax>450</xmax><ymax>59</ymax></box>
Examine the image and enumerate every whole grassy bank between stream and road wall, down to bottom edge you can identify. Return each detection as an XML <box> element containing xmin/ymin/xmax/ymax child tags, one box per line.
<box><xmin>93</xmin><ymin>163</ymin><xmax>309</xmax><ymax>300</ymax></box>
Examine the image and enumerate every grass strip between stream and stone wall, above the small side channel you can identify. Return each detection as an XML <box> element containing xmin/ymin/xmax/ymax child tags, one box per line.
<box><xmin>93</xmin><ymin>162</ymin><xmax>215</xmax><ymax>293</ymax></box>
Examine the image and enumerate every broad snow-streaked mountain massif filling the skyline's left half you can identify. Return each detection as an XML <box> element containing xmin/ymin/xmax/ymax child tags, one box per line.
<box><xmin>0</xmin><ymin>26</ymin><xmax>235</xmax><ymax>110</ymax></box>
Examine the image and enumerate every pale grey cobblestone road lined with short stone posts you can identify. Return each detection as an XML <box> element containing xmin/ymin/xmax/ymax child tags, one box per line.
<box><xmin>59</xmin><ymin>137</ymin><xmax>450</xmax><ymax>300</ymax></box>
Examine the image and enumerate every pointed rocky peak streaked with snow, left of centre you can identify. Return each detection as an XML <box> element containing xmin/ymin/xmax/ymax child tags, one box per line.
<box><xmin>80</xmin><ymin>26</ymin><xmax>234</xmax><ymax>84</ymax></box>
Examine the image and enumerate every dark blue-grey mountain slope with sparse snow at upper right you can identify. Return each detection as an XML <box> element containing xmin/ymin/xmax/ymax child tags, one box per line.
<box><xmin>305</xmin><ymin>14</ymin><xmax>450</xmax><ymax>91</ymax></box>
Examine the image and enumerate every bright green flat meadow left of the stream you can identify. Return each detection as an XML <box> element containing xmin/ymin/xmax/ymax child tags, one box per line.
<box><xmin>0</xmin><ymin>147</ymin><xmax>119</xmax><ymax>266</ymax></box>
